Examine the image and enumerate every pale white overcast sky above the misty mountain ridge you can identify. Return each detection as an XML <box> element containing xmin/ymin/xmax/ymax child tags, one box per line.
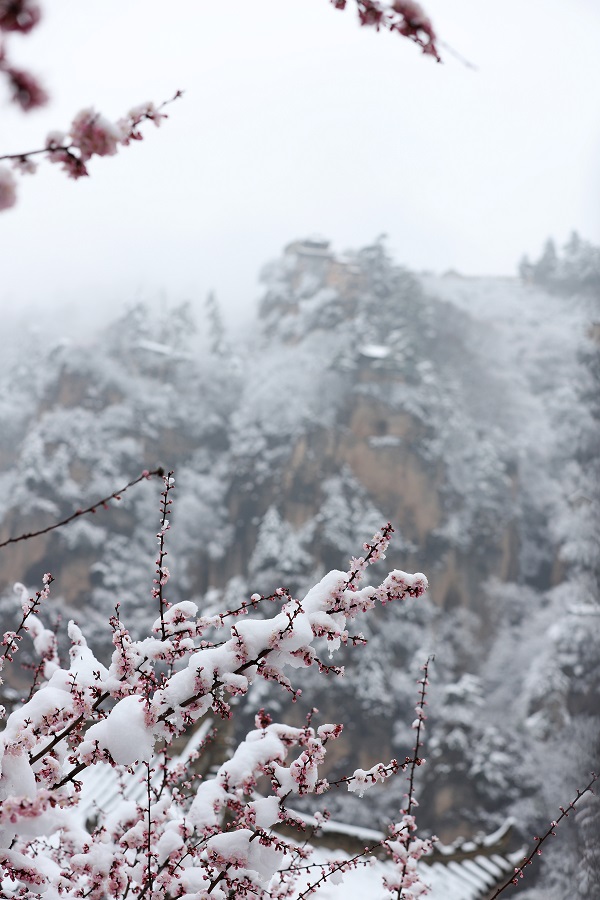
<box><xmin>0</xmin><ymin>0</ymin><xmax>600</xmax><ymax>326</ymax></box>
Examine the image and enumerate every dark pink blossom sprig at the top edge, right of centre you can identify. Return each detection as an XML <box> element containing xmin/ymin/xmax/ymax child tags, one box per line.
<box><xmin>330</xmin><ymin>0</ymin><xmax>441</xmax><ymax>62</ymax></box>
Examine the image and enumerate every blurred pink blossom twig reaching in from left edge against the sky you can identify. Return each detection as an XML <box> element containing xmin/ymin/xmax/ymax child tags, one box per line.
<box><xmin>0</xmin><ymin>91</ymin><xmax>182</xmax><ymax>211</ymax></box>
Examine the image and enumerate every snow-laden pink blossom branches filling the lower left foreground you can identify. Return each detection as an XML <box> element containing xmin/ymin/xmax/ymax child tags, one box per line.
<box><xmin>0</xmin><ymin>473</ymin><xmax>434</xmax><ymax>900</ymax></box>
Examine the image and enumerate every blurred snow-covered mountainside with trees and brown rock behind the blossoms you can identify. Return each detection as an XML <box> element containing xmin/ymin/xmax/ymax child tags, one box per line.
<box><xmin>0</xmin><ymin>236</ymin><xmax>600</xmax><ymax>900</ymax></box>
